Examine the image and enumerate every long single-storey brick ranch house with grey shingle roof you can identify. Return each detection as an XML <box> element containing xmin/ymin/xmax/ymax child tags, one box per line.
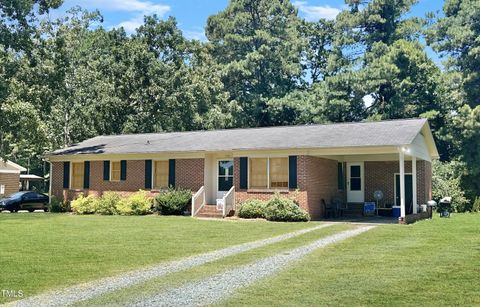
<box><xmin>47</xmin><ymin>119</ymin><xmax>438</xmax><ymax>219</ymax></box>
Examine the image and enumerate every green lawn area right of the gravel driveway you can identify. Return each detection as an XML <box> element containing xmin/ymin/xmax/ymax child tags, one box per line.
<box><xmin>220</xmin><ymin>214</ymin><xmax>480</xmax><ymax>306</ymax></box>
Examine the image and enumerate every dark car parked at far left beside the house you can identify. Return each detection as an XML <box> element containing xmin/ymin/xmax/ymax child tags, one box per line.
<box><xmin>0</xmin><ymin>191</ymin><xmax>49</xmax><ymax>213</ymax></box>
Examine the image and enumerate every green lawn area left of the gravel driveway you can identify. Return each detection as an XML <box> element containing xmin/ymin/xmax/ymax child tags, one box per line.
<box><xmin>0</xmin><ymin>213</ymin><xmax>314</xmax><ymax>303</ymax></box>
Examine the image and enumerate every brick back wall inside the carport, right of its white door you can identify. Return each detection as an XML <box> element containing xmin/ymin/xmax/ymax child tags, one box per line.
<box><xmin>365</xmin><ymin>160</ymin><xmax>432</xmax><ymax>204</ymax></box>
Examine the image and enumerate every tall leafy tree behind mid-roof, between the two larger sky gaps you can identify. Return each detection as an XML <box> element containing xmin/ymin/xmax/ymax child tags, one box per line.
<box><xmin>206</xmin><ymin>0</ymin><xmax>305</xmax><ymax>126</ymax></box>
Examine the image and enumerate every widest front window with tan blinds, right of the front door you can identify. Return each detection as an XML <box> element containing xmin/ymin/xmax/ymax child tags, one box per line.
<box><xmin>248</xmin><ymin>157</ymin><xmax>288</xmax><ymax>189</ymax></box>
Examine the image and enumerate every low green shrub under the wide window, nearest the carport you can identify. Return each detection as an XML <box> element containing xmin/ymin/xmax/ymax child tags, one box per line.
<box><xmin>265</xmin><ymin>194</ymin><xmax>310</xmax><ymax>222</ymax></box>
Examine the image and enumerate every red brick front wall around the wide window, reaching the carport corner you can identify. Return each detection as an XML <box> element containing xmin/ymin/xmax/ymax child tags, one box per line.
<box><xmin>234</xmin><ymin>156</ymin><xmax>337</xmax><ymax>219</ymax></box>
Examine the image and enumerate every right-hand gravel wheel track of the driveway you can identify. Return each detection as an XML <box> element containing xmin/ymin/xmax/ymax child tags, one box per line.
<box><xmin>128</xmin><ymin>226</ymin><xmax>375</xmax><ymax>306</ymax></box>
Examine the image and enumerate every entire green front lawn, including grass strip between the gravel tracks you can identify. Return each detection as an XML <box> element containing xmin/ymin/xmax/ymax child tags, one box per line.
<box><xmin>0</xmin><ymin>214</ymin><xmax>480</xmax><ymax>306</ymax></box>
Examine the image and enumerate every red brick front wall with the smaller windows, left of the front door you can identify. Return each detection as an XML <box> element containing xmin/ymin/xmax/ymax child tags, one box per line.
<box><xmin>52</xmin><ymin>159</ymin><xmax>204</xmax><ymax>200</ymax></box>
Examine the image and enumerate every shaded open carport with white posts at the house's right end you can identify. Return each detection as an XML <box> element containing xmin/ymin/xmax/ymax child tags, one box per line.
<box><xmin>321</xmin><ymin>146</ymin><xmax>431</xmax><ymax>223</ymax></box>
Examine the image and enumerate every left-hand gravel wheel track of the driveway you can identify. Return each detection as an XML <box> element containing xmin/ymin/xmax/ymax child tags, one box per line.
<box><xmin>7</xmin><ymin>223</ymin><xmax>332</xmax><ymax>306</ymax></box>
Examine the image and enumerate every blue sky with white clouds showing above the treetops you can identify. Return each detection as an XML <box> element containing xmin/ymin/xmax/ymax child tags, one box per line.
<box><xmin>52</xmin><ymin>0</ymin><xmax>443</xmax><ymax>40</ymax></box>
